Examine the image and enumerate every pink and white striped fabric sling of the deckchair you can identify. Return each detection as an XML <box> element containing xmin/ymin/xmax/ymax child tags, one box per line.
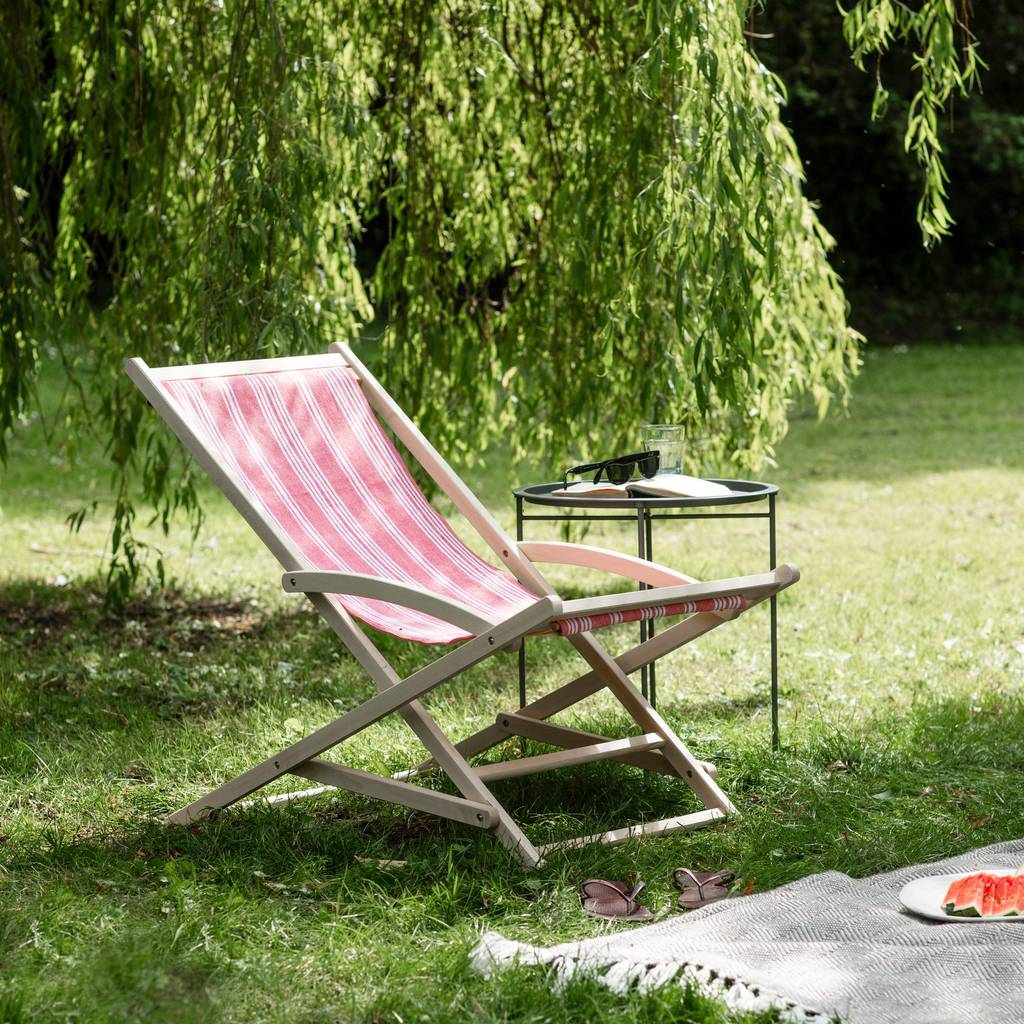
<box><xmin>162</xmin><ymin>366</ymin><xmax>745</xmax><ymax>643</ymax></box>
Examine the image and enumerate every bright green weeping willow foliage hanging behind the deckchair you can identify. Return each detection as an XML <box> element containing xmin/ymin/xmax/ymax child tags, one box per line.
<box><xmin>0</xmin><ymin>0</ymin><xmax>973</xmax><ymax>588</ymax></box>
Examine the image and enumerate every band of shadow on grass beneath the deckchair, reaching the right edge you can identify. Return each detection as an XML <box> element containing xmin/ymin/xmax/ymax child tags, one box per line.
<box><xmin>0</xmin><ymin>698</ymin><xmax>1024</xmax><ymax>892</ymax></box>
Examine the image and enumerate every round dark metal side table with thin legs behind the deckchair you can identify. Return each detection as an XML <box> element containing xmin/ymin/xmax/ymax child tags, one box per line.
<box><xmin>513</xmin><ymin>478</ymin><xmax>779</xmax><ymax>750</ymax></box>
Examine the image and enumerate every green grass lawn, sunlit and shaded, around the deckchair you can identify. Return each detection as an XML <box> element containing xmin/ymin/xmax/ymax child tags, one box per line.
<box><xmin>0</xmin><ymin>345</ymin><xmax>1024</xmax><ymax>1024</ymax></box>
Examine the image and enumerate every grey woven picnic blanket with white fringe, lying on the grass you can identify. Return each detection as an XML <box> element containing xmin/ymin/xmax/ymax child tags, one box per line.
<box><xmin>473</xmin><ymin>840</ymin><xmax>1024</xmax><ymax>1024</ymax></box>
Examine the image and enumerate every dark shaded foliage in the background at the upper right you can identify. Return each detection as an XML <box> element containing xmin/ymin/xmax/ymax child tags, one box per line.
<box><xmin>751</xmin><ymin>0</ymin><xmax>1024</xmax><ymax>333</ymax></box>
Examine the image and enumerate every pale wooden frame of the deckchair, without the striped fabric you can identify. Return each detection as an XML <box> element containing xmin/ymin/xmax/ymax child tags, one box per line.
<box><xmin>125</xmin><ymin>344</ymin><xmax>800</xmax><ymax>867</ymax></box>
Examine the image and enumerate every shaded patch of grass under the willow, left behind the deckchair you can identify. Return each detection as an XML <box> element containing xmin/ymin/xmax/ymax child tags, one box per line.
<box><xmin>0</xmin><ymin>581</ymin><xmax>514</xmax><ymax>729</ymax></box>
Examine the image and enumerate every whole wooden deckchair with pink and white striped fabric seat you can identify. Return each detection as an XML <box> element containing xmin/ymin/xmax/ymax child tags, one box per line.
<box><xmin>126</xmin><ymin>344</ymin><xmax>800</xmax><ymax>867</ymax></box>
